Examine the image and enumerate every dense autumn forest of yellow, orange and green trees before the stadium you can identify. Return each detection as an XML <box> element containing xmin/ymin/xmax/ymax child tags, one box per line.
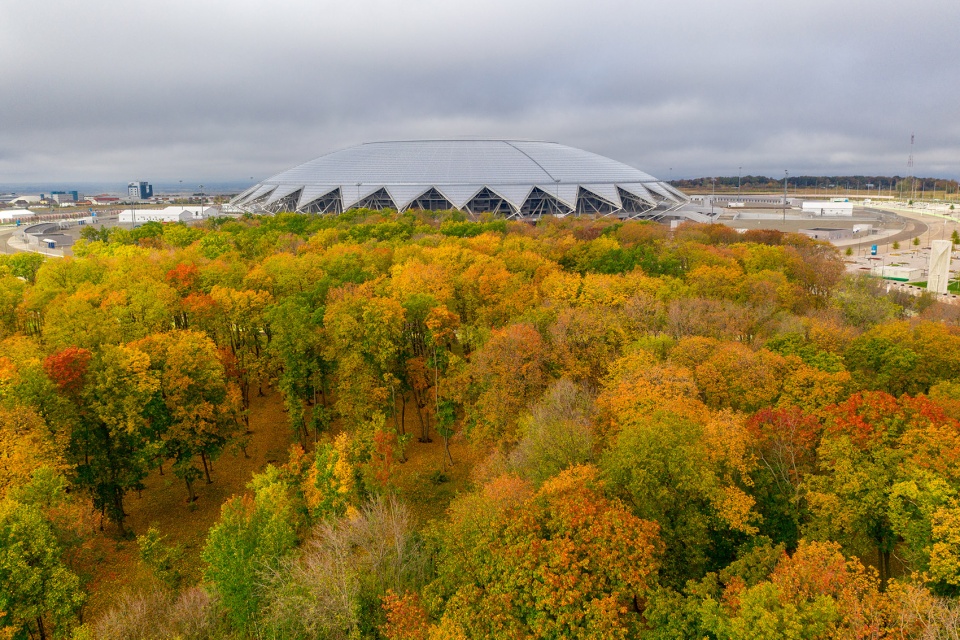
<box><xmin>0</xmin><ymin>210</ymin><xmax>960</xmax><ymax>640</ymax></box>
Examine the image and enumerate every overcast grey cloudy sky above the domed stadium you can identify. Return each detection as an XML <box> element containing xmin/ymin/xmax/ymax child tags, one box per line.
<box><xmin>0</xmin><ymin>0</ymin><xmax>960</xmax><ymax>188</ymax></box>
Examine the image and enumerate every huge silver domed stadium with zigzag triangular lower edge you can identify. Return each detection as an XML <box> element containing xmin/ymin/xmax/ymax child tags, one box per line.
<box><xmin>234</xmin><ymin>139</ymin><xmax>688</xmax><ymax>217</ymax></box>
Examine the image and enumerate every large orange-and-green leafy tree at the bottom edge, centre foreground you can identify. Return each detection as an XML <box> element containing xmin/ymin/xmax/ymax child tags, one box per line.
<box><xmin>425</xmin><ymin>466</ymin><xmax>659</xmax><ymax>638</ymax></box>
